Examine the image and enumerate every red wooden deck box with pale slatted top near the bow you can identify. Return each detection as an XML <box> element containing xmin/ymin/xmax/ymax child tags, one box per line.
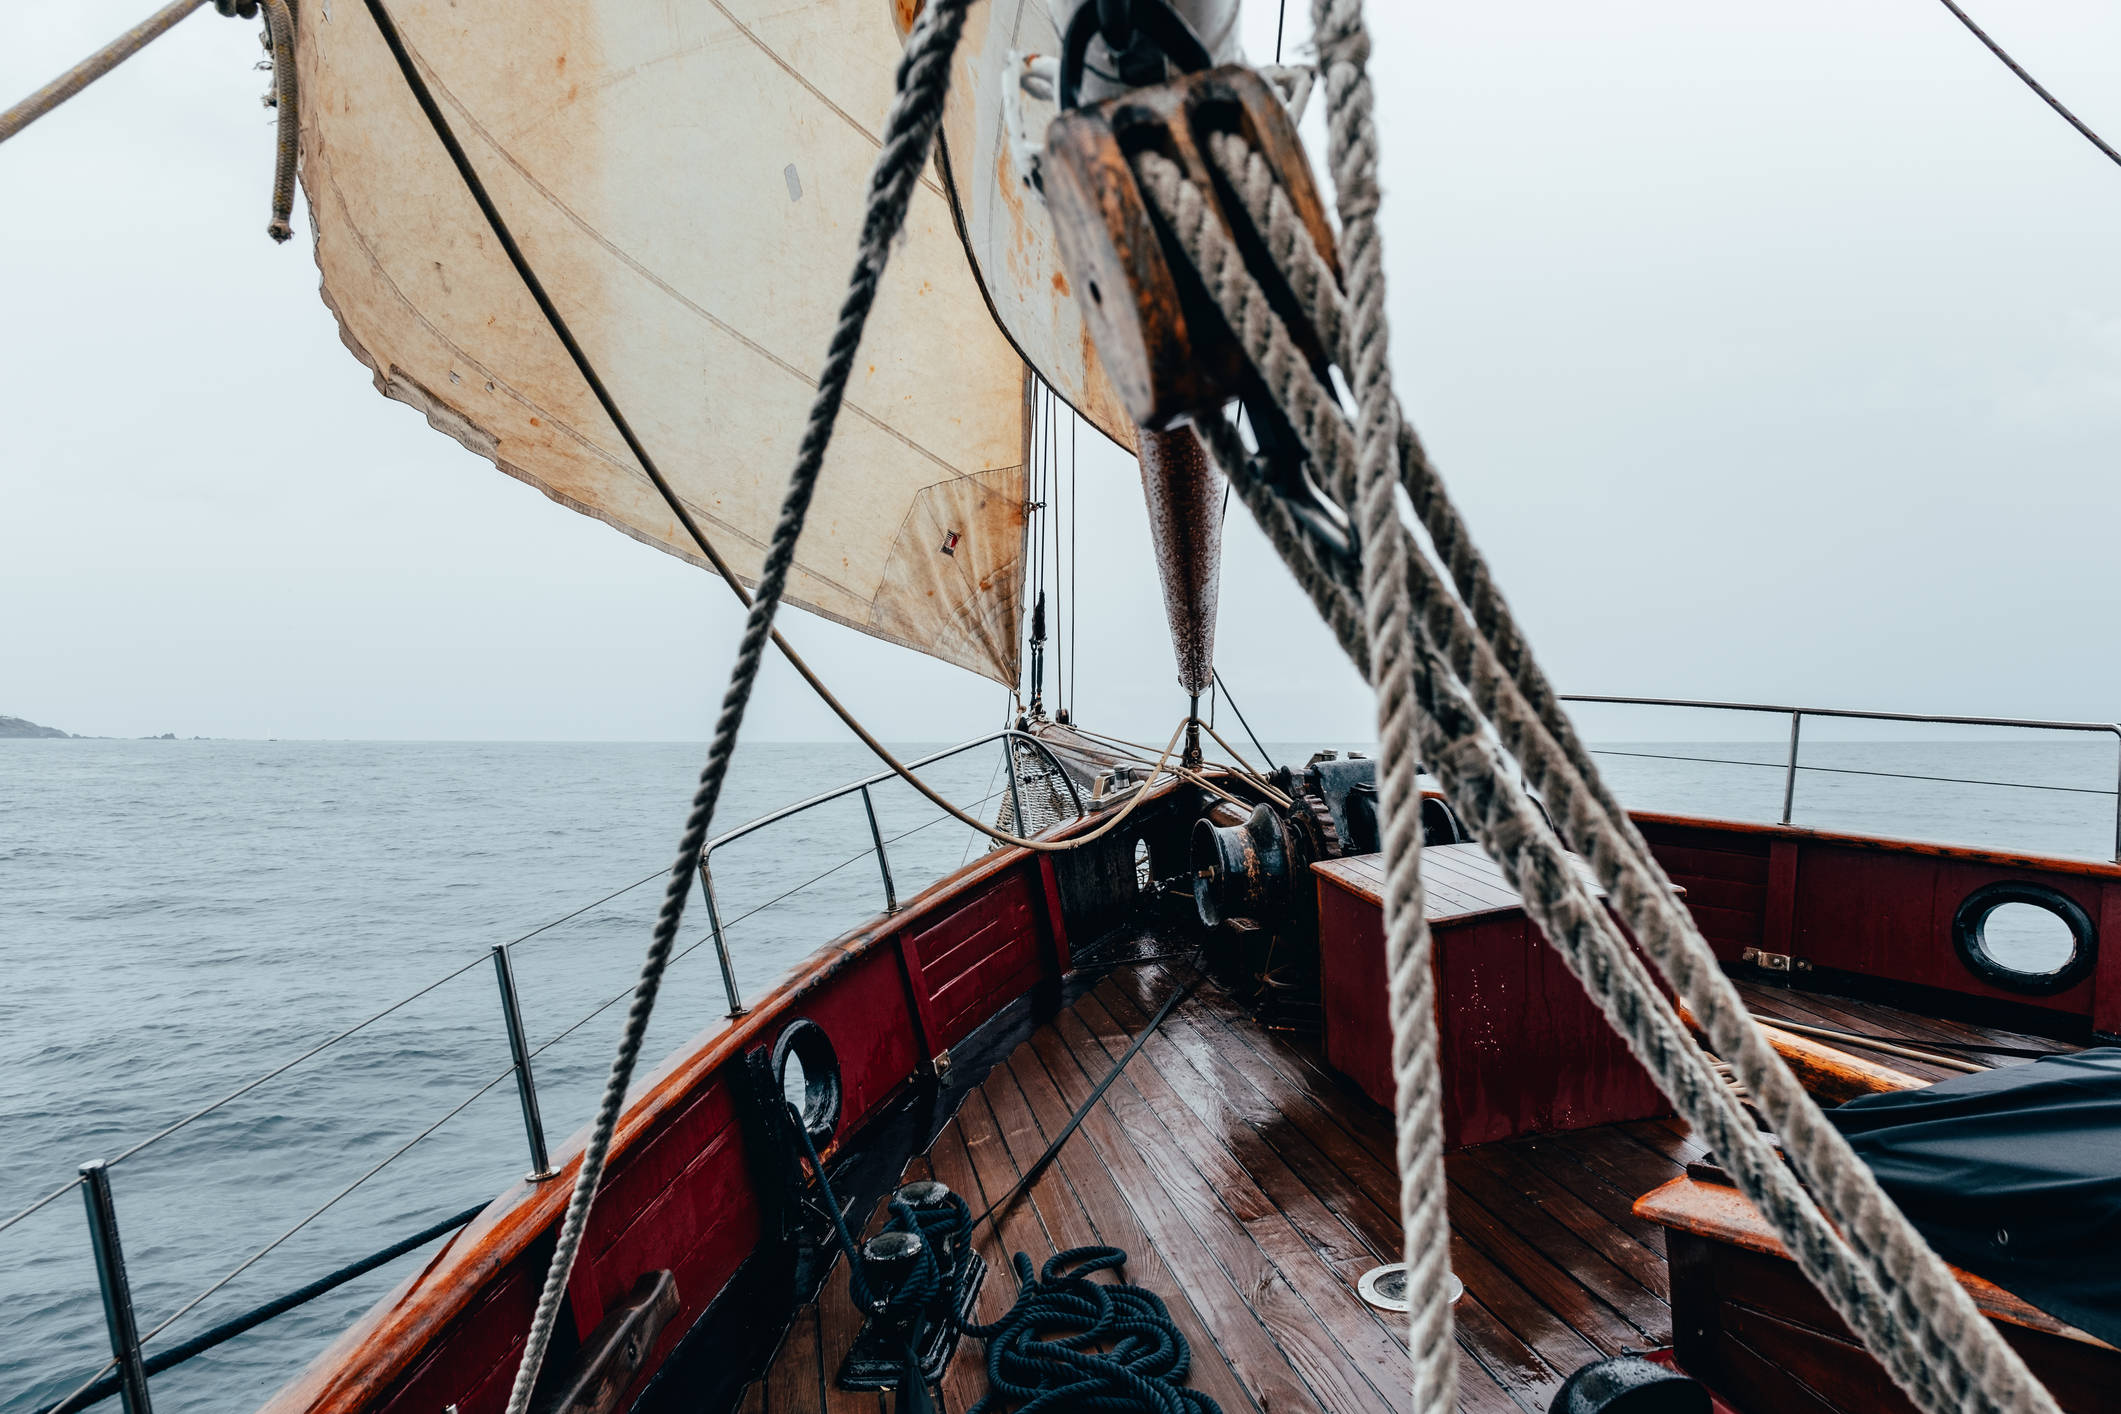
<box><xmin>1317</xmin><ymin>850</ymin><xmax>1669</xmax><ymax>1149</ymax></box>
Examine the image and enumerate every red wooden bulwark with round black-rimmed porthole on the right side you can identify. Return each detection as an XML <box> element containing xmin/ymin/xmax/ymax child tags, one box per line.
<box><xmin>1635</xmin><ymin>814</ymin><xmax>2121</xmax><ymax>1035</ymax></box>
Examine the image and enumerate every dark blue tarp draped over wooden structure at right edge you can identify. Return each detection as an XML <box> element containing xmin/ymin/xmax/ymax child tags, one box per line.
<box><xmin>1826</xmin><ymin>1045</ymin><xmax>2121</xmax><ymax>1346</ymax></box>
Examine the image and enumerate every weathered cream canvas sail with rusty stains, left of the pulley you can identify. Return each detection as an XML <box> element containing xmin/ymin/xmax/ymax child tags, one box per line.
<box><xmin>299</xmin><ymin>0</ymin><xmax>1029</xmax><ymax>683</ymax></box>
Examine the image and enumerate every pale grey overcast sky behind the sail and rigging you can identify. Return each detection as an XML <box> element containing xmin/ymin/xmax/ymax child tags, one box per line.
<box><xmin>0</xmin><ymin>0</ymin><xmax>2121</xmax><ymax>740</ymax></box>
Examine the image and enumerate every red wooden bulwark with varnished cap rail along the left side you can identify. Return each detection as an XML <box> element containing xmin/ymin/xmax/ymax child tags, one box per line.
<box><xmin>265</xmin><ymin>850</ymin><xmax>1067</xmax><ymax>1414</ymax></box>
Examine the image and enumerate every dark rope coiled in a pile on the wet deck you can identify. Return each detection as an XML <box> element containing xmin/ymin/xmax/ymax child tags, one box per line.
<box><xmin>965</xmin><ymin>1247</ymin><xmax>1222</xmax><ymax>1414</ymax></box>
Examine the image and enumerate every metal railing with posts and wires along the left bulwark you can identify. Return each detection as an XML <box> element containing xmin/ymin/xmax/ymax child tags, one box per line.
<box><xmin>0</xmin><ymin>729</ymin><xmax>1086</xmax><ymax>1414</ymax></box>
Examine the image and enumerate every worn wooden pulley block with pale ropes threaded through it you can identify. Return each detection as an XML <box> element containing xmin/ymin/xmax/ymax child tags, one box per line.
<box><xmin>1041</xmin><ymin>64</ymin><xmax>1334</xmax><ymax>428</ymax></box>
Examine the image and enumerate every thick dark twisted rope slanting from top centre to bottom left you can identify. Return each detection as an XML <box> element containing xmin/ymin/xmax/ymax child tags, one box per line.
<box><xmin>507</xmin><ymin>0</ymin><xmax>971</xmax><ymax>1414</ymax></box>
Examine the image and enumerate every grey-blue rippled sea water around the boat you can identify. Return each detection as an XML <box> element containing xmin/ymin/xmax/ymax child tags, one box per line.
<box><xmin>0</xmin><ymin>740</ymin><xmax>2115</xmax><ymax>1414</ymax></box>
